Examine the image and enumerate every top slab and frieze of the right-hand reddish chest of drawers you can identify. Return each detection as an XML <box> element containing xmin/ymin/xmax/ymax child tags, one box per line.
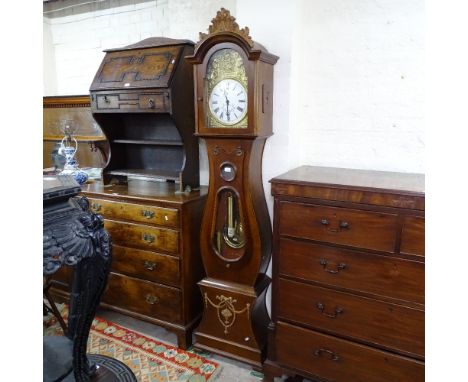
<box><xmin>270</xmin><ymin>166</ymin><xmax>425</xmax><ymax>211</ymax></box>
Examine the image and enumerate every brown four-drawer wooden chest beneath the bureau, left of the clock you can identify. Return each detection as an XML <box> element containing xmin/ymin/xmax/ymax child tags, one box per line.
<box><xmin>49</xmin><ymin>180</ymin><xmax>207</xmax><ymax>349</ymax></box>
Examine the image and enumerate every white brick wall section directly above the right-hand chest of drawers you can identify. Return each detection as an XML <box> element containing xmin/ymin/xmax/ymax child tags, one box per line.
<box><xmin>290</xmin><ymin>0</ymin><xmax>424</xmax><ymax>172</ymax></box>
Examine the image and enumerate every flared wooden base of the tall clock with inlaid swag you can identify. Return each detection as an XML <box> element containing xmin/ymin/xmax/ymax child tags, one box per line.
<box><xmin>194</xmin><ymin>275</ymin><xmax>271</xmax><ymax>369</ymax></box>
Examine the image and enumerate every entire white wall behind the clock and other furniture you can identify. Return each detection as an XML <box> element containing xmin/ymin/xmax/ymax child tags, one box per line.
<box><xmin>44</xmin><ymin>0</ymin><xmax>424</xmax><ymax>184</ymax></box>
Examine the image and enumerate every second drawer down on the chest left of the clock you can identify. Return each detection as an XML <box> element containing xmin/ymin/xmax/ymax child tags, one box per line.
<box><xmin>104</xmin><ymin>220</ymin><xmax>179</xmax><ymax>254</ymax></box>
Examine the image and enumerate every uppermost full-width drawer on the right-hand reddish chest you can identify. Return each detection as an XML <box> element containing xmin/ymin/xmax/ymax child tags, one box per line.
<box><xmin>278</xmin><ymin>238</ymin><xmax>424</xmax><ymax>304</ymax></box>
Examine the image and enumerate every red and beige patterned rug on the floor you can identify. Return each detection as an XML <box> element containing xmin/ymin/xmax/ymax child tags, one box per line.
<box><xmin>43</xmin><ymin>305</ymin><xmax>221</xmax><ymax>382</ymax></box>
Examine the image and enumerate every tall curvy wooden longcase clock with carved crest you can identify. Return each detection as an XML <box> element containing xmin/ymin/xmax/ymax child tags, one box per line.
<box><xmin>187</xmin><ymin>8</ymin><xmax>278</xmax><ymax>366</ymax></box>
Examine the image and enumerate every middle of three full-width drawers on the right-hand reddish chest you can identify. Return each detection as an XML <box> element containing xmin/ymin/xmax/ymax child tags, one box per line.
<box><xmin>277</xmin><ymin>278</ymin><xmax>424</xmax><ymax>357</ymax></box>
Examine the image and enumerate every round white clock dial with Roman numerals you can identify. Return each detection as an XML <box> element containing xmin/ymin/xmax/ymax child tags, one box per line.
<box><xmin>209</xmin><ymin>79</ymin><xmax>247</xmax><ymax>125</ymax></box>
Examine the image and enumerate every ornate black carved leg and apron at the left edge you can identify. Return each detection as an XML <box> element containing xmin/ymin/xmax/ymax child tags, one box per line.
<box><xmin>43</xmin><ymin>197</ymin><xmax>115</xmax><ymax>382</ymax></box>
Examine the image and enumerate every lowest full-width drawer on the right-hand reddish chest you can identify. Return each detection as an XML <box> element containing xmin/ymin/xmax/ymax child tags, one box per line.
<box><xmin>275</xmin><ymin>322</ymin><xmax>424</xmax><ymax>382</ymax></box>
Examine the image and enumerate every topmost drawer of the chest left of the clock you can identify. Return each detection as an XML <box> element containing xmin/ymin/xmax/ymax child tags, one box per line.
<box><xmin>89</xmin><ymin>198</ymin><xmax>179</xmax><ymax>227</ymax></box>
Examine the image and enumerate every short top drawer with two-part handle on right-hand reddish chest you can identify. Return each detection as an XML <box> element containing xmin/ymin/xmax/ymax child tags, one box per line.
<box><xmin>279</xmin><ymin>201</ymin><xmax>397</xmax><ymax>252</ymax></box>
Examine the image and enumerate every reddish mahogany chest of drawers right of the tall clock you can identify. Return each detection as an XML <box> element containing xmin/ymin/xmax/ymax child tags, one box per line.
<box><xmin>264</xmin><ymin>166</ymin><xmax>425</xmax><ymax>382</ymax></box>
